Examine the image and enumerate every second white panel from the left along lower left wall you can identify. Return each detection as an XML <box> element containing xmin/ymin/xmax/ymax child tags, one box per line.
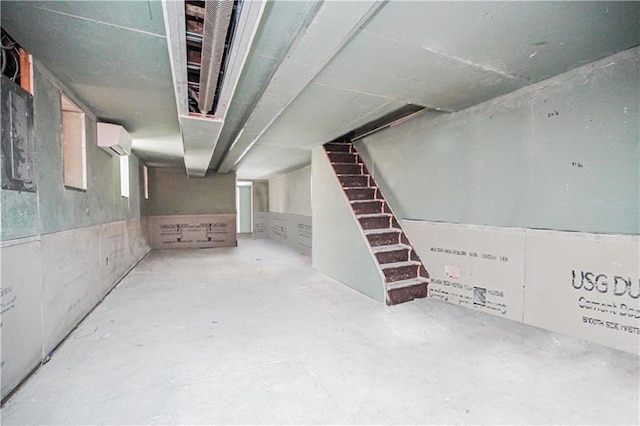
<box><xmin>41</xmin><ymin>226</ymin><xmax>101</xmax><ymax>353</ymax></box>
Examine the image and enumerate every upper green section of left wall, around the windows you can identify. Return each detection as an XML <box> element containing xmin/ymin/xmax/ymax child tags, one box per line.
<box><xmin>1</xmin><ymin>60</ymin><xmax>140</xmax><ymax>240</ymax></box>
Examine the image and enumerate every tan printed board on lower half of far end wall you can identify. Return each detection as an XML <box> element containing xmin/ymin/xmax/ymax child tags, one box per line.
<box><xmin>149</xmin><ymin>214</ymin><xmax>237</xmax><ymax>249</ymax></box>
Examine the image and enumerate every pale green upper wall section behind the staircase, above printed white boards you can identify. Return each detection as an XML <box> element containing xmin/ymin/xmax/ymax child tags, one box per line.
<box><xmin>269</xmin><ymin>166</ymin><xmax>311</xmax><ymax>216</ymax></box>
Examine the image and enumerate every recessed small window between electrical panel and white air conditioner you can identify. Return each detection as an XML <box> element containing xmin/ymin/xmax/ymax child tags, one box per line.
<box><xmin>60</xmin><ymin>93</ymin><xmax>87</xmax><ymax>190</ymax></box>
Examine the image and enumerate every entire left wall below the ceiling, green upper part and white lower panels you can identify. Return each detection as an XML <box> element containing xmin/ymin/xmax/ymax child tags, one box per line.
<box><xmin>0</xmin><ymin>60</ymin><xmax>149</xmax><ymax>398</ymax></box>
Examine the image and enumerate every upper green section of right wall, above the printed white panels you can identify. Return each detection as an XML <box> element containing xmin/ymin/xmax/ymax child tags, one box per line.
<box><xmin>357</xmin><ymin>48</ymin><xmax>640</xmax><ymax>234</ymax></box>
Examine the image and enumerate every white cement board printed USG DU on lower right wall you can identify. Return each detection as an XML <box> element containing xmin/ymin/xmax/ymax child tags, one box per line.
<box><xmin>524</xmin><ymin>230</ymin><xmax>640</xmax><ymax>354</ymax></box>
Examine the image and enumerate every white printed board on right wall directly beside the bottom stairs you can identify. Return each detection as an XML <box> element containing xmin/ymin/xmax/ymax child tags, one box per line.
<box><xmin>402</xmin><ymin>220</ymin><xmax>525</xmax><ymax>321</ymax></box>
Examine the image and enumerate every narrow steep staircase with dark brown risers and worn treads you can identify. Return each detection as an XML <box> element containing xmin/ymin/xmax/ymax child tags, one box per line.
<box><xmin>324</xmin><ymin>140</ymin><xmax>429</xmax><ymax>305</ymax></box>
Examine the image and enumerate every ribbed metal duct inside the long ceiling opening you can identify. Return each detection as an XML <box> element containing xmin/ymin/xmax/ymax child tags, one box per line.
<box><xmin>198</xmin><ymin>0</ymin><xmax>233</xmax><ymax>114</ymax></box>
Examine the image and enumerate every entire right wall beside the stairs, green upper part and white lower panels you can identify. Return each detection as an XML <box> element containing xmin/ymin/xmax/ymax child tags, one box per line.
<box><xmin>357</xmin><ymin>48</ymin><xmax>640</xmax><ymax>353</ymax></box>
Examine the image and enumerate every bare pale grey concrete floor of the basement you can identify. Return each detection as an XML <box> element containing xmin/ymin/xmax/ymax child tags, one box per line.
<box><xmin>2</xmin><ymin>239</ymin><xmax>640</xmax><ymax>425</ymax></box>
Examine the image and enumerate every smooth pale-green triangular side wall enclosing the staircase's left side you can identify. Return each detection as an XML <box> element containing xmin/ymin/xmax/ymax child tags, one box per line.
<box><xmin>311</xmin><ymin>146</ymin><xmax>387</xmax><ymax>303</ymax></box>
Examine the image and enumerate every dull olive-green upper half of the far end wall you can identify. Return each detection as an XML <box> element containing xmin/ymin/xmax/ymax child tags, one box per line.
<box><xmin>145</xmin><ymin>167</ymin><xmax>236</xmax><ymax>216</ymax></box>
